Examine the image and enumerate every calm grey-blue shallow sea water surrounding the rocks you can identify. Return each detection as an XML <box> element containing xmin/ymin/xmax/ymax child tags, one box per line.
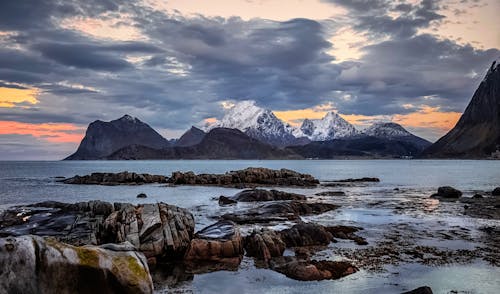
<box><xmin>0</xmin><ymin>160</ymin><xmax>500</xmax><ymax>293</ymax></box>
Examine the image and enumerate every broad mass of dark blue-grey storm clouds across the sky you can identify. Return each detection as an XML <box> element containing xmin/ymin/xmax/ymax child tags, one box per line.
<box><xmin>0</xmin><ymin>0</ymin><xmax>500</xmax><ymax>136</ymax></box>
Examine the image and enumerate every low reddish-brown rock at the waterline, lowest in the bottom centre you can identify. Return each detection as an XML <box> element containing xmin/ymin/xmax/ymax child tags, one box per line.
<box><xmin>271</xmin><ymin>256</ymin><xmax>358</xmax><ymax>281</ymax></box>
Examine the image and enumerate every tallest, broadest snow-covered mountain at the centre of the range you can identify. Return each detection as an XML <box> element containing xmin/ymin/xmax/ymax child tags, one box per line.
<box><xmin>207</xmin><ymin>100</ymin><xmax>300</xmax><ymax>147</ymax></box>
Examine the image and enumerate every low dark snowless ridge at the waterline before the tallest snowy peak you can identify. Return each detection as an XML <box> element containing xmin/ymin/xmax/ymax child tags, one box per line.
<box><xmin>106</xmin><ymin>128</ymin><xmax>301</xmax><ymax>160</ymax></box>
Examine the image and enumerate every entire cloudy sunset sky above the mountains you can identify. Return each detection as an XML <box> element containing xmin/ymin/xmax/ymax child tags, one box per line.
<box><xmin>0</xmin><ymin>0</ymin><xmax>500</xmax><ymax>160</ymax></box>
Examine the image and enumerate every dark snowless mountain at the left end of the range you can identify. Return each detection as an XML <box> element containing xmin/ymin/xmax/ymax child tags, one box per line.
<box><xmin>65</xmin><ymin>115</ymin><xmax>169</xmax><ymax>160</ymax></box>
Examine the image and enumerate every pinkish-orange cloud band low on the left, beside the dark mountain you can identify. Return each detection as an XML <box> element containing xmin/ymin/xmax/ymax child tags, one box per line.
<box><xmin>0</xmin><ymin>121</ymin><xmax>85</xmax><ymax>143</ymax></box>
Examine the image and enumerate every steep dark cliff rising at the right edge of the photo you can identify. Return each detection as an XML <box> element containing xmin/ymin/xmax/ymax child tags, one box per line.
<box><xmin>423</xmin><ymin>60</ymin><xmax>500</xmax><ymax>158</ymax></box>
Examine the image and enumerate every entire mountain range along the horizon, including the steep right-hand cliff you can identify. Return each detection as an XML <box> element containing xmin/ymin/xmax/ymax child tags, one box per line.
<box><xmin>65</xmin><ymin>61</ymin><xmax>500</xmax><ymax>160</ymax></box>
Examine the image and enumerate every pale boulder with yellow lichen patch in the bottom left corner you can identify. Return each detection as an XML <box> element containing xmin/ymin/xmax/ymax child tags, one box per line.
<box><xmin>0</xmin><ymin>235</ymin><xmax>153</xmax><ymax>293</ymax></box>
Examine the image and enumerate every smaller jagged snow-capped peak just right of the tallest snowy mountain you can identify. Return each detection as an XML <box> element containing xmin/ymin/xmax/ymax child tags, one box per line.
<box><xmin>293</xmin><ymin>111</ymin><xmax>359</xmax><ymax>141</ymax></box>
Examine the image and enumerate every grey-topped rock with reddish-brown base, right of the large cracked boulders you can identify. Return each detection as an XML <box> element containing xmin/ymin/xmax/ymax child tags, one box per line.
<box><xmin>184</xmin><ymin>220</ymin><xmax>243</xmax><ymax>264</ymax></box>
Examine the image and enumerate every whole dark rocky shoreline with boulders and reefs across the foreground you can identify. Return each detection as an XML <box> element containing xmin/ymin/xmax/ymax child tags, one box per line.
<box><xmin>0</xmin><ymin>168</ymin><xmax>500</xmax><ymax>293</ymax></box>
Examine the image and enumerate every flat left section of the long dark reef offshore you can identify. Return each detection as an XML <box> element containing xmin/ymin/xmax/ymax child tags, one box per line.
<box><xmin>61</xmin><ymin>171</ymin><xmax>167</xmax><ymax>186</ymax></box>
